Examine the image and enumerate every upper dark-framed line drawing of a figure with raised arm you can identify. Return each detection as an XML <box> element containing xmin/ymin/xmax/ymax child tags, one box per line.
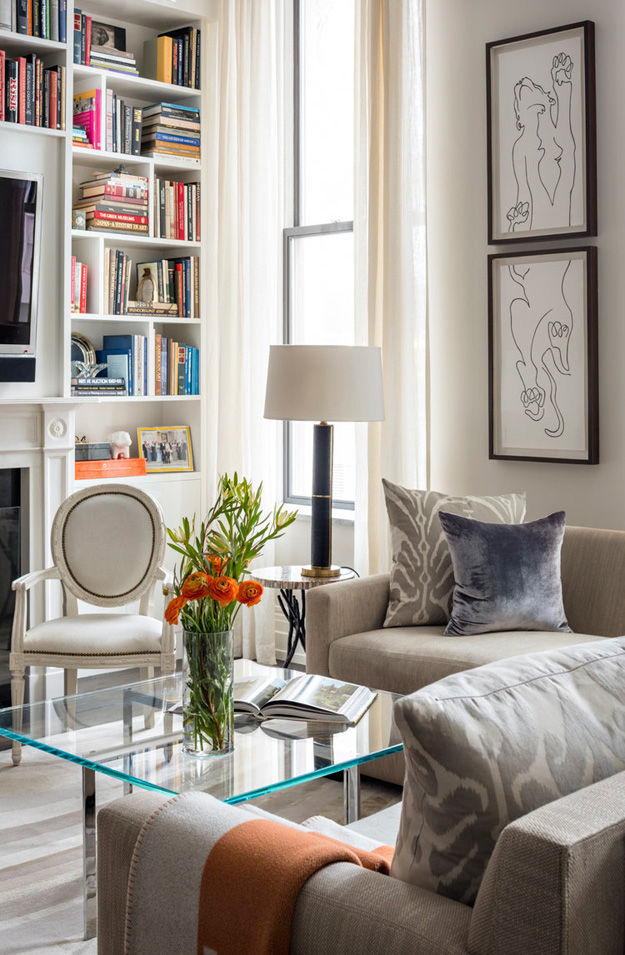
<box><xmin>486</xmin><ymin>20</ymin><xmax>597</xmax><ymax>244</ymax></box>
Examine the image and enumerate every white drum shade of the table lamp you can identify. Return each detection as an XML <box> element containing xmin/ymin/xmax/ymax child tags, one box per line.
<box><xmin>265</xmin><ymin>345</ymin><xmax>384</xmax><ymax>421</ymax></box>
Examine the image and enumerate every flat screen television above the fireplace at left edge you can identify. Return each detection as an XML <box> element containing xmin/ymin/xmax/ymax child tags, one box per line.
<box><xmin>0</xmin><ymin>169</ymin><xmax>43</xmax><ymax>381</ymax></box>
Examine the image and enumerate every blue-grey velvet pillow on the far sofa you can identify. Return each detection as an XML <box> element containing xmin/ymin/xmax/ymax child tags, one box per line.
<box><xmin>439</xmin><ymin>511</ymin><xmax>571</xmax><ymax>636</ymax></box>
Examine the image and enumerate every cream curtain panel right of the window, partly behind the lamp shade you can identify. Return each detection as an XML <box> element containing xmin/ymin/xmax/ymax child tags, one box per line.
<box><xmin>354</xmin><ymin>0</ymin><xmax>428</xmax><ymax>574</ymax></box>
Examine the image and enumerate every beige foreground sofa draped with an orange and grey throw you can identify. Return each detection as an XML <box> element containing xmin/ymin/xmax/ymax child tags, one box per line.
<box><xmin>98</xmin><ymin>773</ymin><xmax>625</xmax><ymax>955</ymax></box>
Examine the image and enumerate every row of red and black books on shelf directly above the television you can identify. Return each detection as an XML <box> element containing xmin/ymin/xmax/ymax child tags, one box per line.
<box><xmin>0</xmin><ymin>50</ymin><xmax>65</xmax><ymax>129</ymax></box>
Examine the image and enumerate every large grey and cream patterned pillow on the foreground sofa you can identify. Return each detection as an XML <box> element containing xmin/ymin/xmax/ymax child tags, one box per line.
<box><xmin>391</xmin><ymin>637</ymin><xmax>625</xmax><ymax>904</ymax></box>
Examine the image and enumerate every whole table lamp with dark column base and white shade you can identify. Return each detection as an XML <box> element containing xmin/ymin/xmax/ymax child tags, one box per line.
<box><xmin>264</xmin><ymin>345</ymin><xmax>384</xmax><ymax>577</ymax></box>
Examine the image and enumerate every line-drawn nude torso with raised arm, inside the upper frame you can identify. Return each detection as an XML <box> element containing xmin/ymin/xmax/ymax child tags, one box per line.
<box><xmin>506</xmin><ymin>53</ymin><xmax>577</xmax><ymax>232</ymax></box>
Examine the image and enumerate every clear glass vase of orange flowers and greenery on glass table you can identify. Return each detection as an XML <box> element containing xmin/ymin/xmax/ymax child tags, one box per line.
<box><xmin>165</xmin><ymin>473</ymin><xmax>296</xmax><ymax>756</ymax></box>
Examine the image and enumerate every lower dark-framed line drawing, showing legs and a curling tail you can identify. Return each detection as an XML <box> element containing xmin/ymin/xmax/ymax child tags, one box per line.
<box><xmin>488</xmin><ymin>247</ymin><xmax>599</xmax><ymax>464</ymax></box>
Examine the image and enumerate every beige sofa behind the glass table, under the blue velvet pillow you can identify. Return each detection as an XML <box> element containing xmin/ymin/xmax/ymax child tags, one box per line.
<box><xmin>306</xmin><ymin>527</ymin><xmax>625</xmax><ymax>784</ymax></box>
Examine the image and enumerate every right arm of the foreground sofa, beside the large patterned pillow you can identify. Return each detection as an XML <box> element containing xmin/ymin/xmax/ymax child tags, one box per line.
<box><xmin>469</xmin><ymin>772</ymin><xmax>625</xmax><ymax>955</ymax></box>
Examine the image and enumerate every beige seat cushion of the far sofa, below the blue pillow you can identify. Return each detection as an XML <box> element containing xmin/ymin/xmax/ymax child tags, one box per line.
<box><xmin>329</xmin><ymin>626</ymin><xmax>606</xmax><ymax>694</ymax></box>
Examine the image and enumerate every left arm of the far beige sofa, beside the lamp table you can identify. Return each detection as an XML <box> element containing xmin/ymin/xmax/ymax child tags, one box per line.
<box><xmin>306</xmin><ymin>574</ymin><xmax>390</xmax><ymax>676</ymax></box>
